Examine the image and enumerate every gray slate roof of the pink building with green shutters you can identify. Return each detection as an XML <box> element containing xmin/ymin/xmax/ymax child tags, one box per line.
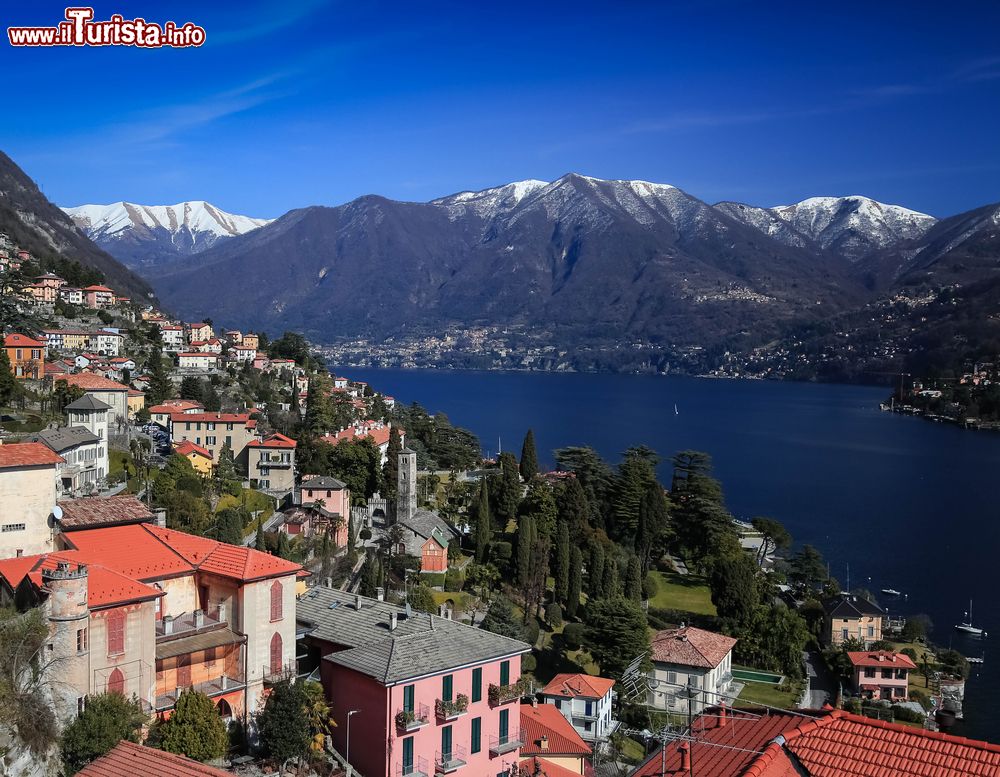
<box><xmin>296</xmin><ymin>587</ymin><xmax>531</xmax><ymax>685</ymax></box>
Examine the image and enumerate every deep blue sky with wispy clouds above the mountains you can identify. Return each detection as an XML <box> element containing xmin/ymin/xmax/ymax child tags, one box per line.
<box><xmin>0</xmin><ymin>0</ymin><xmax>1000</xmax><ymax>217</ymax></box>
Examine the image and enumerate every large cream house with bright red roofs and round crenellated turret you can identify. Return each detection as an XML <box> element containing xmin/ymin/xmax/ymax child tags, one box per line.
<box><xmin>0</xmin><ymin>520</ymin><xmax>305</xmax><ymax>718</ymax></box>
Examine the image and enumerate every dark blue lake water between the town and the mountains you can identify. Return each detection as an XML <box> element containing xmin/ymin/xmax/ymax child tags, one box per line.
<box><xmin>338</xmin><ymin>368</ymin><xmax>1000</xmax><ymax>741</ymax></box>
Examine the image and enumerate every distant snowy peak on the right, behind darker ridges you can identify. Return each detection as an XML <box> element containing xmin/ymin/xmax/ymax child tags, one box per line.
<box><xmin>770</xmin><ymin>195</ymin><xmax>937</xmax><ymax>260</ymax></box>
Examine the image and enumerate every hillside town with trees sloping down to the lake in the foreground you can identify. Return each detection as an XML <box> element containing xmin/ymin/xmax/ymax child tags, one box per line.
<box><xmin>0</xmin><ymin>235</ymin><xmax>1000</xmax><ymax>777</ymax></box>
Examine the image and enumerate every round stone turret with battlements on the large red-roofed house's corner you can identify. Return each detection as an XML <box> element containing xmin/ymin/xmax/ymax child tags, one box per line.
<box><xmin>42</xmin><ymin>561</ymin><xmax>90</xmax><ymax>724</ymax></box>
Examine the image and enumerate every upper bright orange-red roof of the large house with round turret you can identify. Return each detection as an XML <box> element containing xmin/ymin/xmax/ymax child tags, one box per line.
<box><xmin>66</xmin><ymin>523</ymin><xmax>302</xmax><ymax>583</ymax></box>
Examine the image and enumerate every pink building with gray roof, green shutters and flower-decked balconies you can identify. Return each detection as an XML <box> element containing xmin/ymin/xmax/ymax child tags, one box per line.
<box><xmin>297</xmin><ymin>587</ymin><xmax>530</xmax><ymax>777</ymax></box>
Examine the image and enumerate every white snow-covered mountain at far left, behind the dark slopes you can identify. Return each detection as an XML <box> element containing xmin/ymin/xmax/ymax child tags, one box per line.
<box><xmin>63</xmin><ymin>200</ymin><xmax>271</xmax><ymax>267</ymax></box>
